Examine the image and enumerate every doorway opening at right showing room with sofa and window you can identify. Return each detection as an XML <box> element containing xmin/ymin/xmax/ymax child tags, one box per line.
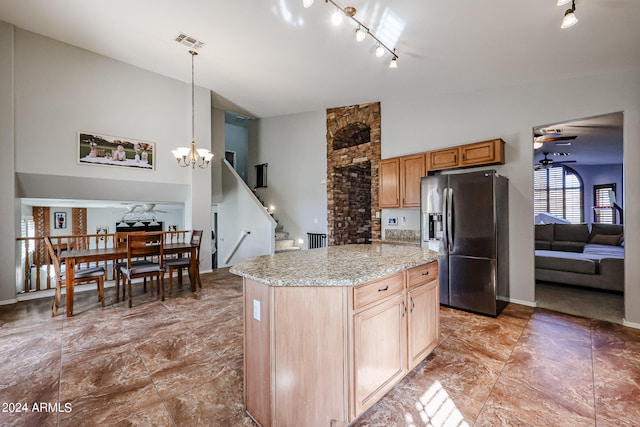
<box><xmin>533</xmin><ymin>112</ymin><xmax>625</xmax><ymax>323</ymax></box>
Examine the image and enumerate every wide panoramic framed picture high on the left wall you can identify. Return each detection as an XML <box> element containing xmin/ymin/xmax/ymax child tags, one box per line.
<box><xmin>78</xmin><ymin>132</ymin><xmax>155</xmax><ymax>170</ymax></box>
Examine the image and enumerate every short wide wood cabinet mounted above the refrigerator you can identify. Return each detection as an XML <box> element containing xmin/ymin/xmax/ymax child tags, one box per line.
<box><xmin>427</xmin><ymin>138</ymin><xmax>504</xmax><ymax>171</ymax></box>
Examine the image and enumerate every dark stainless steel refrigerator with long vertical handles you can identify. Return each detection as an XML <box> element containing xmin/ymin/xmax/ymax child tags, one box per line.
<box><xmin>421</xmin><ymin>170</ymin><xmax>509</xmax><ymax>316</ymax></box>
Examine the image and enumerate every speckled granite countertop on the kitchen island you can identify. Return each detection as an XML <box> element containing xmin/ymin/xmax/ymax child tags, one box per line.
<box><xmin>229</xmin><ymin>244</ymin><xmax>442</xmax><ymax>286</ymax></box>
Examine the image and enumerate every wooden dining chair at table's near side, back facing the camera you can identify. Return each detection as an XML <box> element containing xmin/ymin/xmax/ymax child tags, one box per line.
<box><xmin>120</xmin><ymin>231</ymin><xmax>164</xmax><ymax>308</ymax></box>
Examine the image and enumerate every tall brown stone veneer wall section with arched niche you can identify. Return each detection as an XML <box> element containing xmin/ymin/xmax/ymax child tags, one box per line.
<box><xmin>327</xmin><ymin>102</ymin><xmax>381</xmax><ymax>245</ymax></box>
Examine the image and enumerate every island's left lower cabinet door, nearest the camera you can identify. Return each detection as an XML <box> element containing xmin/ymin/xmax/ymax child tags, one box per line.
<box><xmin>353</xmin><ymin>292</ymin><xmax>407</xmax><ymax>417</ymax></box>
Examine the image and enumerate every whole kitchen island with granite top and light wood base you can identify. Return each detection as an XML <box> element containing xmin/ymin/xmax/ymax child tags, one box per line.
<box><xmin>230</xmin><ymin>244</ymin><xmax>440</xmax><ymax>427</ymax></box>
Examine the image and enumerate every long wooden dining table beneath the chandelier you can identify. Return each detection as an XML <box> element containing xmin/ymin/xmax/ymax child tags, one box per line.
<box><xmin>60</xmin><ymin>242</ymin><xmax>199</xmax><ymax>317</ymax></box>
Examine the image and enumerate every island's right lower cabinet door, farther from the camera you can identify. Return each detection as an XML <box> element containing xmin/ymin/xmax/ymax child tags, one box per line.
<box><xmin>407</xmin><ymin>280</ymin><xmax>440</xmax><ymax>369</ymax></box>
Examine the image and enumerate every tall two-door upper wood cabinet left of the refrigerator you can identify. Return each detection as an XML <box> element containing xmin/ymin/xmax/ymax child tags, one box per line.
<box><xmin>378</xmin><ymin>154</ymin><xmax>426</xmax><ymax>208</ymax></box>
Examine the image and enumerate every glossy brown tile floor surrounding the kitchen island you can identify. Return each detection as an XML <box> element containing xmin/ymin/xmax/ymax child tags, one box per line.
<box><xmin>0</xmin><ymin>270</ymin><xmax>640</xmax><ymax>427</ymax></box>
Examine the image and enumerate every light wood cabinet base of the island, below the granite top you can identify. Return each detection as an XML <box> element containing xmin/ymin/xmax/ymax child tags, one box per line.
<box><xmin>244</xmin><ymin>262</ymin><xmax>440</xmax><ymax>427</ymax></box>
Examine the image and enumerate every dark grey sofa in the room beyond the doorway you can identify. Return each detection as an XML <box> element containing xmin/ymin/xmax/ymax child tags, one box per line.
<box><xmin>535</xmin><ymin>224</ymin><xmax>624</xmax><ymax>292</ymax></box>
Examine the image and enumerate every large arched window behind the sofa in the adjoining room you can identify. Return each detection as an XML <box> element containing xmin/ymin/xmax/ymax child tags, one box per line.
<box><xmin>533</xmin><ymin>166</ymin><xmax>584</xmax><ymax>224</ymax></box>
